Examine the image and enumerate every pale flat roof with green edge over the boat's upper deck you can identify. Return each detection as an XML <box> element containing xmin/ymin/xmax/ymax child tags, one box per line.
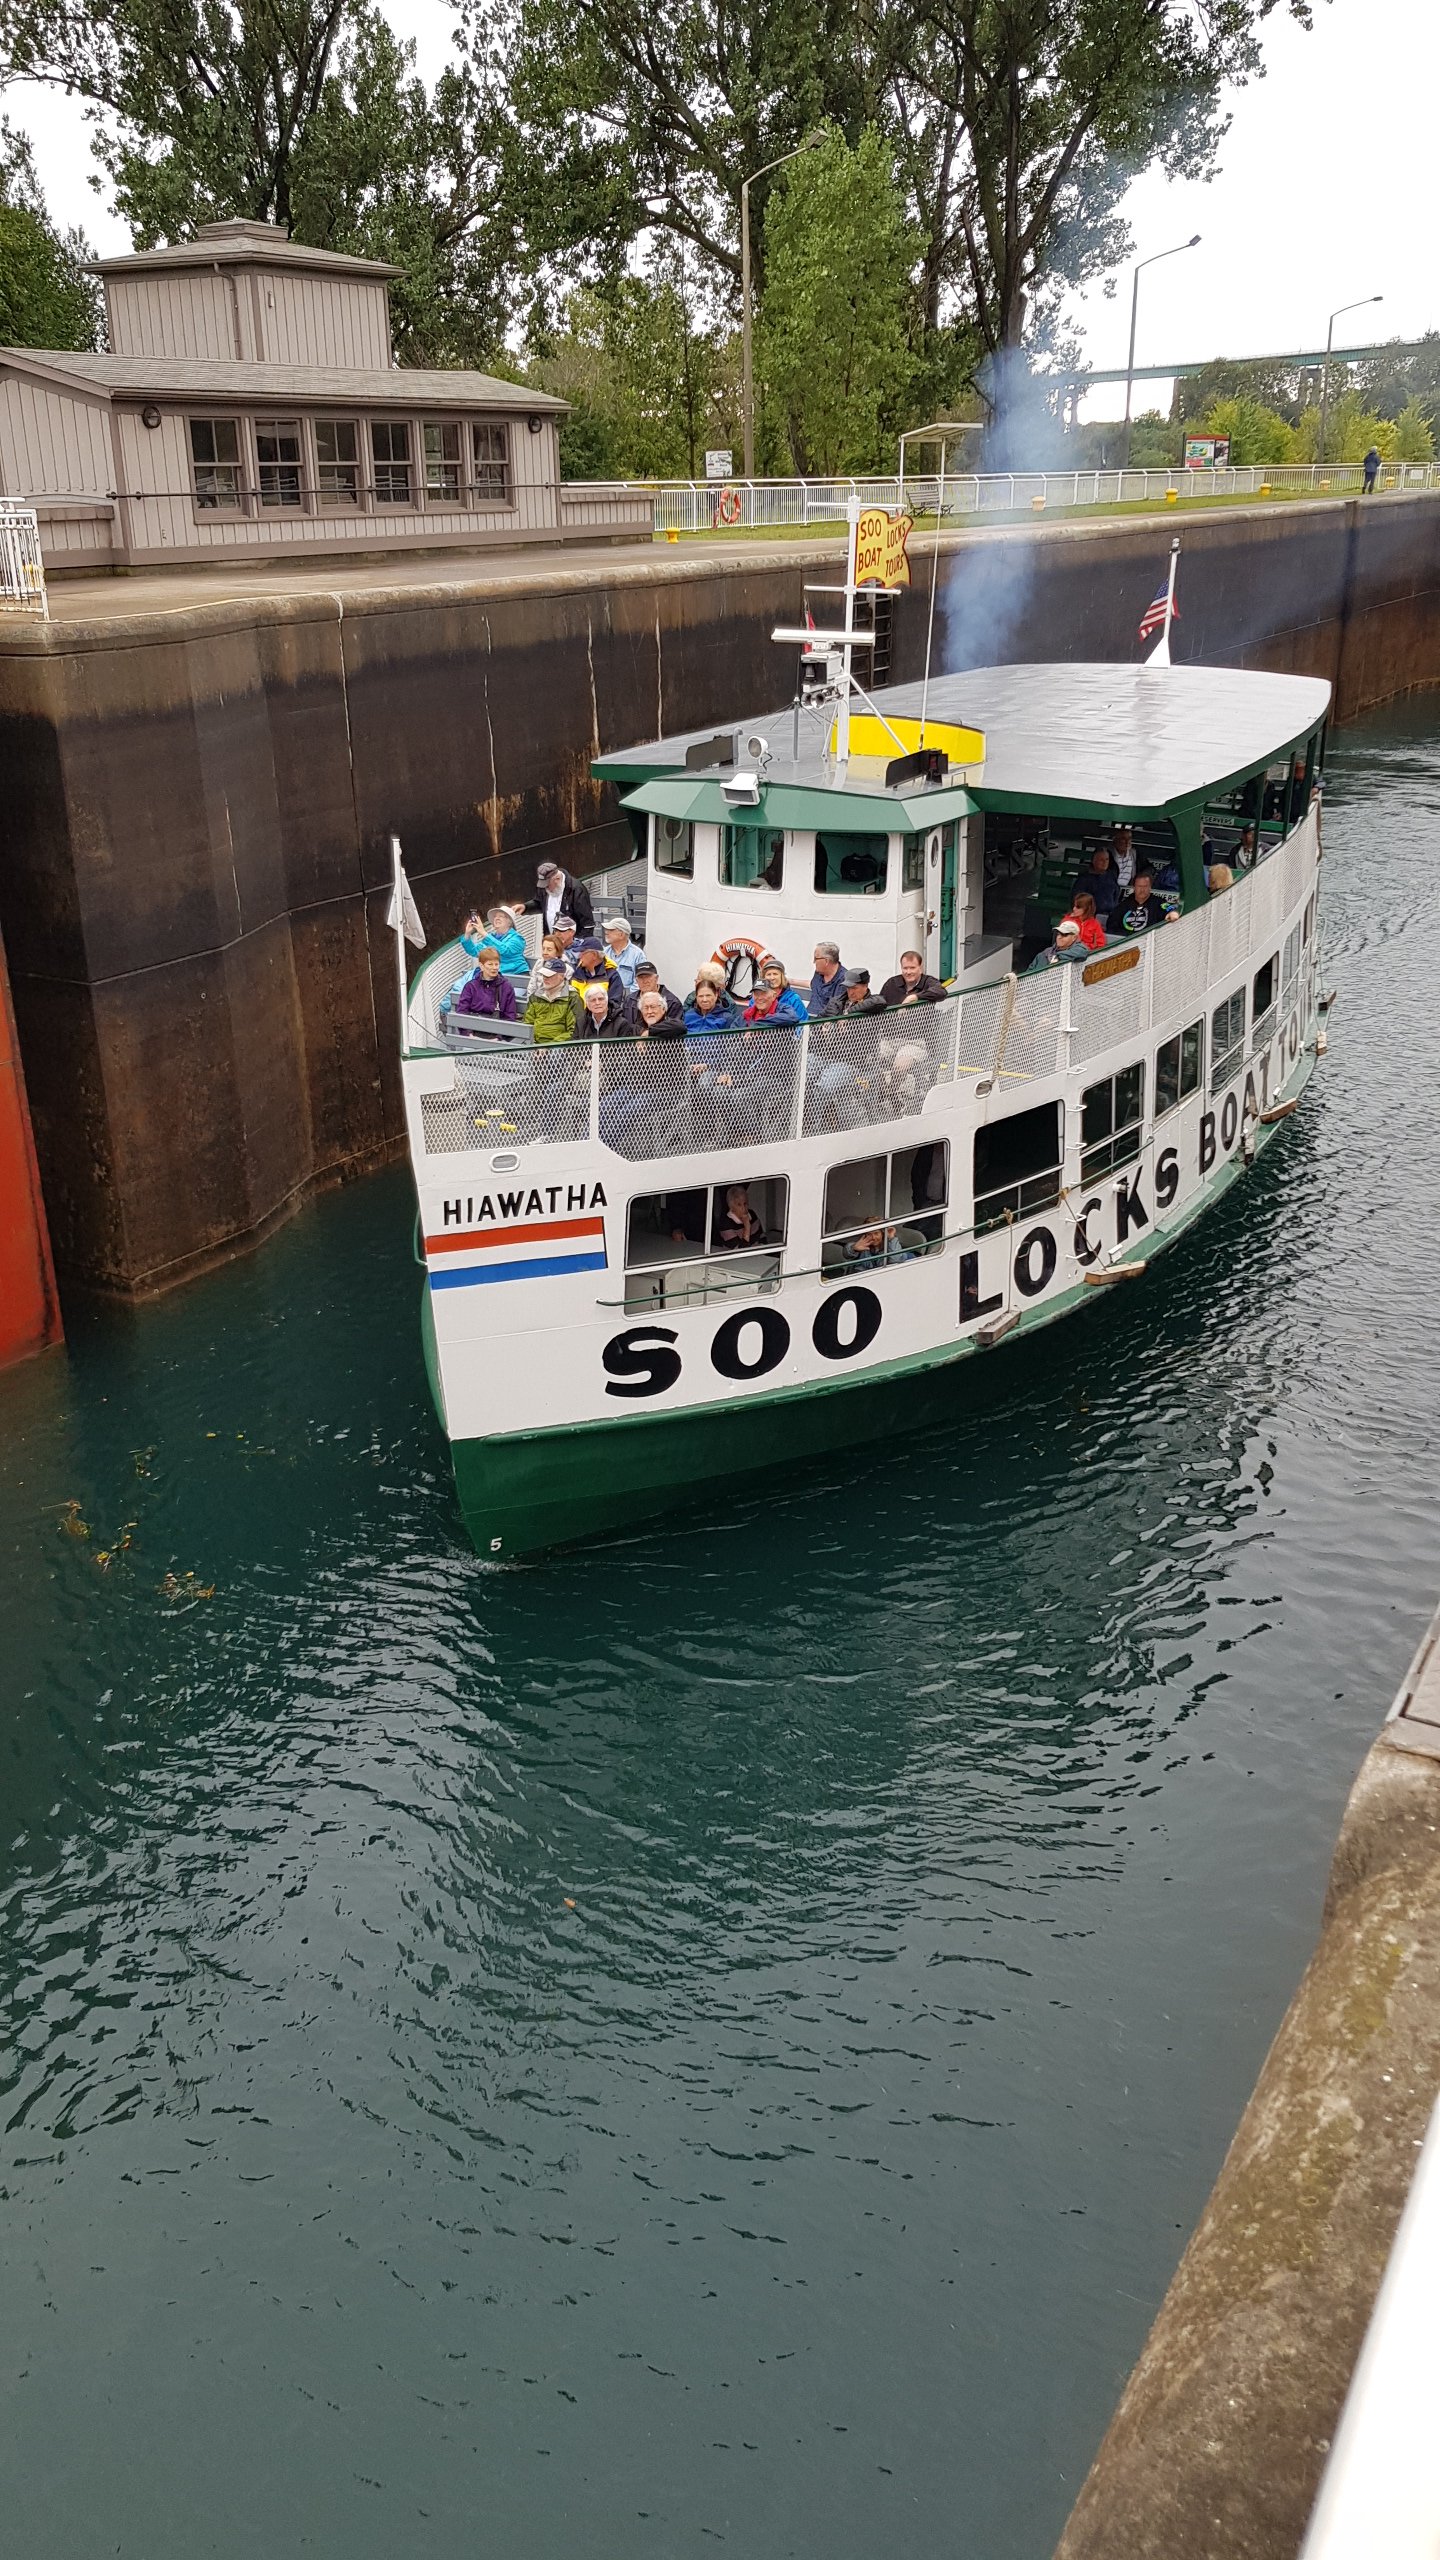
<box><xmin>592</xmin><ymin>666</ymin><xmax>1330</xmax><ymax>835</ymax></box>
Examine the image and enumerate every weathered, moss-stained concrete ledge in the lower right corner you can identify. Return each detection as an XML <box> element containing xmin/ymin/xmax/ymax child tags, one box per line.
<box><xmin>1056</xmin><ymin>1651</ymin><xmax>1440</xmax><ymax>2560</ymax></box>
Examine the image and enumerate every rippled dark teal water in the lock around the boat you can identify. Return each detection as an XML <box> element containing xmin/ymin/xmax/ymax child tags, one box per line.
<box><xmin>0</xmin><ymin>704</ymin><xmax>1440</xmax><ymax>2560</ymax></box>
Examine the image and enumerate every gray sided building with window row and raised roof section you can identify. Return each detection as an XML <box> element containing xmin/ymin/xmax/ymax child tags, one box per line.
<box><xmin>0</xmin><ymin>223</ymin><xmax>651</xmax><ymax>576</ymax></box>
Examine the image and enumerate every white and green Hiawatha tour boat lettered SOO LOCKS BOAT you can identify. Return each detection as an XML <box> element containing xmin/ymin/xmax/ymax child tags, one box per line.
<box><xmin>392</xmin><ymin>529</ymin><xmax>1330</xmax><ymax>1559</ymax></box>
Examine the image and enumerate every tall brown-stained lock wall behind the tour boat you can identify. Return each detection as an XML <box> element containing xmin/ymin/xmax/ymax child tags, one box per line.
<box><xmin>0</xmin><ymin>497</ymin><xmax>1440</xmax><ymax>1293</ymax></box>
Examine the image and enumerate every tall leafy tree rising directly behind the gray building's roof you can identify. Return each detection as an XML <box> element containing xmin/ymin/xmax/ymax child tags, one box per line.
<box><xmin>0</xmin><ymin>0</ymin><xmax>515</xmax><ymax>361</ymax></box>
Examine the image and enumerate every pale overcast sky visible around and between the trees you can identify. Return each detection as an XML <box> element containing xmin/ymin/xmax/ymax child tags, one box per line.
<box><xmin>5</xmin><ymin>0</ymin><xmax>1440</xmax><ymax>417</ymax></box>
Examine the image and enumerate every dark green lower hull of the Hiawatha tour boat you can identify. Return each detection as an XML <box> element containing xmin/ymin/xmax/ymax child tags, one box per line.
<box><xmin>435</xmin><ymin>1029</ymin><xmax>1314</xmax><ymax>1556</ymax></box>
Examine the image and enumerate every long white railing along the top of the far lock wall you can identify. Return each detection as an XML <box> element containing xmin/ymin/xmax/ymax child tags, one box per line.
<box><xmin>623</xmin><ymin>463</ymin><xmax>1440</xmax><ymax>535</ymax></box>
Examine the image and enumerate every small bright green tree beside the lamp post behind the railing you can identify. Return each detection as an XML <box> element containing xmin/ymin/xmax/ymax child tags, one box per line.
<box><xmin>758</xmin><ymin>125</ymin><xmax>917</xmax><ymax>474</ymax></box>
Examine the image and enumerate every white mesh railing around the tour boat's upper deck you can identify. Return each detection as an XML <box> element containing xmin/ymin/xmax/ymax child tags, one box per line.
<box><xmin>413</xmin><ymin>827</ymin><xmax>1314</xmax><ymax>1165</ymax></box>
